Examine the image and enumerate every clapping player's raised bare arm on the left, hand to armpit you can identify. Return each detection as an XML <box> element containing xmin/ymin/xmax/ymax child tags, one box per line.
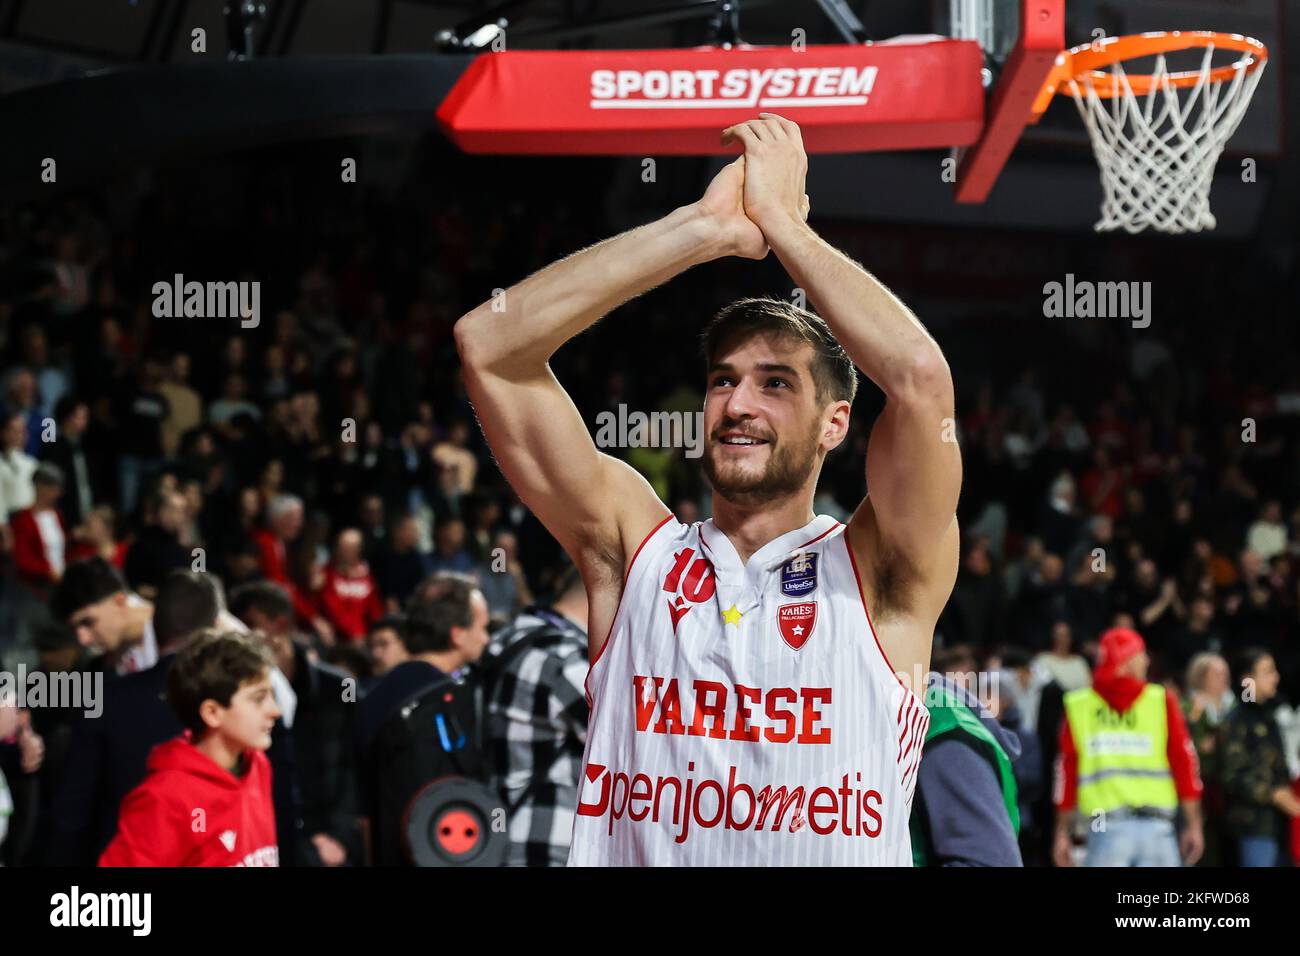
<box><xmin>455</xmin><ymin>160</ymin><xmax>767</xmax><ymax>590</ymax></box>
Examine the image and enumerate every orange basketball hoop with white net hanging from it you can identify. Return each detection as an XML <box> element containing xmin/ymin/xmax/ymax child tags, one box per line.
<box><xmin>1034</xmin><ymin>30</ymin><xmax>1269</xmax><ymax>233</ymax></box>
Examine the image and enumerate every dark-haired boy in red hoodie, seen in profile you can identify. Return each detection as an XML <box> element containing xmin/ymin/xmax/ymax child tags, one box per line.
<box><xmin>99</xmin><ymin>631</ymin><xmax>280</xmax><ymax>866</ymax></box>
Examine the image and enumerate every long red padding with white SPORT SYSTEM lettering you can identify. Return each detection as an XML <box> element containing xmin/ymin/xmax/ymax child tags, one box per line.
<box><xmin>438</xmin><ymin>40</ymin><xmax>984</xmax><ymax>156</ymax></box>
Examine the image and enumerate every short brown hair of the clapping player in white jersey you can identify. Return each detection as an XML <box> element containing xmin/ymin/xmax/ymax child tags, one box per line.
<box><xmin>699</xmin><ymin>299</ymin><xmax>858</xmax><ymax>405</ymax></box>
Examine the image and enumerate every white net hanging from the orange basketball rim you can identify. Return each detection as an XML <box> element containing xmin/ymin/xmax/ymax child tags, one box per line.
<box><xmin>1069</xmin><ymin>46</ymin><xmax>1265</xmax><ymax>233</ymax></box>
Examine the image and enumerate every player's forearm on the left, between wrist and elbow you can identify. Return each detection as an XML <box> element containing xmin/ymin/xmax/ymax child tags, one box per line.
<box><xmin>455</xmin><ymin>204</ymin><xmax>727</xmax><ymax>375</ymax></box>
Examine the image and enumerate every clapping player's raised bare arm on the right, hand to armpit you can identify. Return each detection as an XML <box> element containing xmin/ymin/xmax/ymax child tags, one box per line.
<box><xmin>724</xmin><ymin>113</ymin><xmax>962</xmax><ymax>671</ymax></box>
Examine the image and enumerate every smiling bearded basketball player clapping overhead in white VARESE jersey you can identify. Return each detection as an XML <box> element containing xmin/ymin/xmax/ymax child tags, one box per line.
<box><xmin>455</xmin><ymin>113</ymin><xmax>961</xmax><ymax>866</ymax></box>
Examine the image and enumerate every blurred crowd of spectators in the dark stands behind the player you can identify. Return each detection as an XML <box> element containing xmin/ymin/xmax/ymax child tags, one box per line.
<box><xmin>0</xmin><ymin>136</ymin><xmax>1300</xmax><ymax>868</ymax></box>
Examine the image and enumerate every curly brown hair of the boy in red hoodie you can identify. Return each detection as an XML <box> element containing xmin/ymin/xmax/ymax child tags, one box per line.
<box><xmin>166</xmin><ymin>628</ymin><xmax>274</xmax><ymax>740</ymax></box>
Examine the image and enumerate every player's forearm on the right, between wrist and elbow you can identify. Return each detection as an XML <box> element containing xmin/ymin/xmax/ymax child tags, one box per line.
<box><xmin>763</xmin><ymin>217</ymin><xmax>952</xmax><ymax>405</ymax></box>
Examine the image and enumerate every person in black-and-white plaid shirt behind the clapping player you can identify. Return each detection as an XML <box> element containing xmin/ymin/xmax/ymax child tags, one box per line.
<box><xmin>486</xmin><ymin>567</ymin><xmax>589</xmax><ymax>866</ymax></box>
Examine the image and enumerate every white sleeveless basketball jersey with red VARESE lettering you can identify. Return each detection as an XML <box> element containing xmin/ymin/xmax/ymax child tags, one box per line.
<box><xmin>569</xmin><ymin>515</ymin><xmax>930</xmax><ymax>866</ymax></box>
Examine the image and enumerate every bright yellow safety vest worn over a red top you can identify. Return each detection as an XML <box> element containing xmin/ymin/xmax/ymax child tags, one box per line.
<box><xmin>1065</xmin><ymin>684</ymin><xmax>1178</xmax><ymax>816</ymax></box>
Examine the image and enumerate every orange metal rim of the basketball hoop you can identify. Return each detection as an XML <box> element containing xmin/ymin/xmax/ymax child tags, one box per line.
<box><xmin>1034</xmin><ymin>30</ymin><xmax>1269</xmax><ymax>117</ymax></box>
